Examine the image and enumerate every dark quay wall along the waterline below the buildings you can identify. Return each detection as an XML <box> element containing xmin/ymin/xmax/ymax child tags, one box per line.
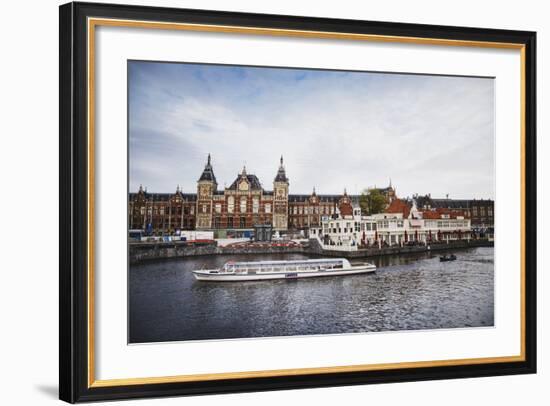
<box><xmin>128</xmin><ymin>239</ymin><xmax>494</xmax><ymax>264</ymax></box>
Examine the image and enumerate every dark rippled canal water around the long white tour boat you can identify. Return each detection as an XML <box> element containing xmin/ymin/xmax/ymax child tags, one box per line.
<box><xmin>129</xmin><ymin>248</ymin><xmax>494</xmax><ymax>343</ymax></box>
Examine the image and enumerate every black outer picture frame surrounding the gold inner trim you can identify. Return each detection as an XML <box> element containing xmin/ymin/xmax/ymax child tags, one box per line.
<box><xmin>59</xmin><ymin>3</ymin><xmax>536</xmax><ymax>403</ymax></box>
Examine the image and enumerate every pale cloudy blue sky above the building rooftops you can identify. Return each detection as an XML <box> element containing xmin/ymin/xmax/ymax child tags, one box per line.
<box><xmin>129</xmin><ymin>61</ymin><xmax>494</xmax><ymax>198</ymax></box>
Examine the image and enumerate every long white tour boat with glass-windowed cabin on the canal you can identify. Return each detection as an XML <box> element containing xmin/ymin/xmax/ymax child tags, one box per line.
<box><xmin>193</xmin><ymin>258</ymin><xmax>376</xmax><ymax>282</ymax></box>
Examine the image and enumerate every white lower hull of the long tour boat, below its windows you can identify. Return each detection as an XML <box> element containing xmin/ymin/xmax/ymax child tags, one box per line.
<box><xmin>193</xmin><ymin>264</ymin><xmax>376</xmax><ymax>282</ymax></box>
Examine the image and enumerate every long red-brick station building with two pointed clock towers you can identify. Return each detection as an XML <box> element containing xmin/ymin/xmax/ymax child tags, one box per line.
<box><xmin>128</xmin><ymin>155</ymin><xmax>359</xmax><ymax>235</ymax></box>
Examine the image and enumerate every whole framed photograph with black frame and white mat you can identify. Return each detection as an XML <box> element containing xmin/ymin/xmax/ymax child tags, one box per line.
<box><xmin>59</xmin><ymin>3</ymin><xmax>536</xmax><ymax>402</ymax></box>
